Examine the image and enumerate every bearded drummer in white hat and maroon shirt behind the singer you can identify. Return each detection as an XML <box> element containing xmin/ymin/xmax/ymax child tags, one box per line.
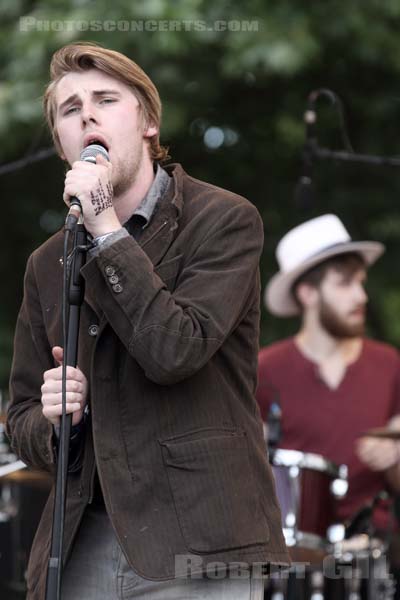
<box><xmin>257</xmin><ymin>215</ymin><xmax>400</xmax><ymax>532</ymax></box>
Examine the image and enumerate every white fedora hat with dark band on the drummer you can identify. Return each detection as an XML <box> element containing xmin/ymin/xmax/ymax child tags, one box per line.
<box><xmin>264</xmin><ymin>215</ymin><xmax>385</xmax><ymax>317</ymax></box>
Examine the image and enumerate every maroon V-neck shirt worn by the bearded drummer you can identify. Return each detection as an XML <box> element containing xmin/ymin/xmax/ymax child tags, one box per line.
<box><xmin>257</xmin><ymin>338</ymin><xmax>400</xmax><ymax>527</ymax></box>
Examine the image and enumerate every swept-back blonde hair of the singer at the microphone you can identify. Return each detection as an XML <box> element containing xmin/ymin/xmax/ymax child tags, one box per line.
<box><xmin>43</xmin><ymin>42</ymin><xmax>169</xmax><ymax>161</ymax></box>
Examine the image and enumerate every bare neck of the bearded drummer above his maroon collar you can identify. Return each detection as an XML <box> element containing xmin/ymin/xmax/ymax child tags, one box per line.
<box><xmin>295</xmin><ymin>318</ymin><xmax>362</xmax><ymax>364</ymax></box>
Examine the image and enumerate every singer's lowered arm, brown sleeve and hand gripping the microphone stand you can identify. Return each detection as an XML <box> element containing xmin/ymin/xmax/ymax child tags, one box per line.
<box><xmin>7</xmin><ymin>257</ymin><xmax>87</xmax><ymax>471</ymax></box>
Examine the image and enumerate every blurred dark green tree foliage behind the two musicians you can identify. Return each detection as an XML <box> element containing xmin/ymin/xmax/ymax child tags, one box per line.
<box><xmin>0</xmin><ymin>0</ymin><xmax>400</xmax><ymax>387</ymax></box>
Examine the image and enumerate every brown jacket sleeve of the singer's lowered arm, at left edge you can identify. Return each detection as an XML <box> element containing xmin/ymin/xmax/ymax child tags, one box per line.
<box><xmin>6</xmin><ymin>256</ymin><xmax>54</xmax><ymax>471</ymax></box>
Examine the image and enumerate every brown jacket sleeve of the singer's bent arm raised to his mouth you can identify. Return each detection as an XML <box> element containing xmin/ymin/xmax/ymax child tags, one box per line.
<box><xmin>82</xmin><ymin>201</ymin><xmax>263</xmax><ymax>385</ymax></box>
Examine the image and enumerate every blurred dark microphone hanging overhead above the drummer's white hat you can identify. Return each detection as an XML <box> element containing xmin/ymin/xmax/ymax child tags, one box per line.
<box><xmin>294</xmin><ymin>90</ymin><xmax>320</xmax><ymax>209</ymax></box>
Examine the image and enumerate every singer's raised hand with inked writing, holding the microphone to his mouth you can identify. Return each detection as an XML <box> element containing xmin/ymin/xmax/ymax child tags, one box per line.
<box><xmin>63</xmin><ymin>144</ymin><xmax>121</xmax><ymax>237</ymax></box>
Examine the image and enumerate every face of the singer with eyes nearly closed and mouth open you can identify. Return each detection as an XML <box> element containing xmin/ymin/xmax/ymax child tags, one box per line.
<box><xmin>55</xmin><ymin>69</ymin><xmax>157</xmax><ymax>196</ymax></box>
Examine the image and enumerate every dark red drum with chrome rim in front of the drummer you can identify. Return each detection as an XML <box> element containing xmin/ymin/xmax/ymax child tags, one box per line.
<box><xmin>271</xmin><ymin>449</ymin><xmax>347</xmax><ymax>562</ymax></box>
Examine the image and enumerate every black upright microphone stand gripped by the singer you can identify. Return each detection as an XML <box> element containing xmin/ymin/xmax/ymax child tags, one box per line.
<box><xmin>46</xmin><ymin>224</ymin><xmax>87</xmax><ymax>600</ymax></box>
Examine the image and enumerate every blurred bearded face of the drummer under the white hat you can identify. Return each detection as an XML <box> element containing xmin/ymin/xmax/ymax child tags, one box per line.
<box><xmin>318</xmin><ymin>268</ymin><xmax>368</xmax><ymax>338</ymax></box>
